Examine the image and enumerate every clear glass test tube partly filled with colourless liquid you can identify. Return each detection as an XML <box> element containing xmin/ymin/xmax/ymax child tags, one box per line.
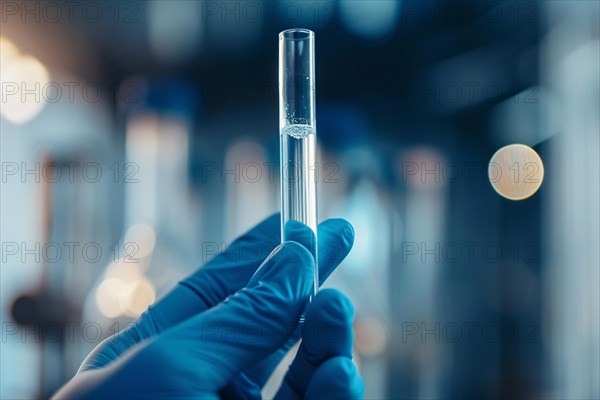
<box><xmin>279</xmin><ymin>29</ymin><xmax>319</xmax><ymax>297</ymax></box>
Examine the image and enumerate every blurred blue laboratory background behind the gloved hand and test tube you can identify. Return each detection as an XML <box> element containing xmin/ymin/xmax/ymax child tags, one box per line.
<box><xmin>0</xmin><ymin>0</ymin><xmax>600</xmax><ymax>399</ymax></box>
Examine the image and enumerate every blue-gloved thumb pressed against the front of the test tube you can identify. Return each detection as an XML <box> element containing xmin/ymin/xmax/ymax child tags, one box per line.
<box><xmin>164</xmin><ymin>242</ymin><xmax>314</xmax><ymax>391</ymax></box>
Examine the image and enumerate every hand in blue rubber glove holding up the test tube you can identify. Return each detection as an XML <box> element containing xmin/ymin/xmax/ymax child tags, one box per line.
<box><xmin>55</xmin><ymin>215</ymin><xmax>363</xmax><ymax>399</ymax></box>
